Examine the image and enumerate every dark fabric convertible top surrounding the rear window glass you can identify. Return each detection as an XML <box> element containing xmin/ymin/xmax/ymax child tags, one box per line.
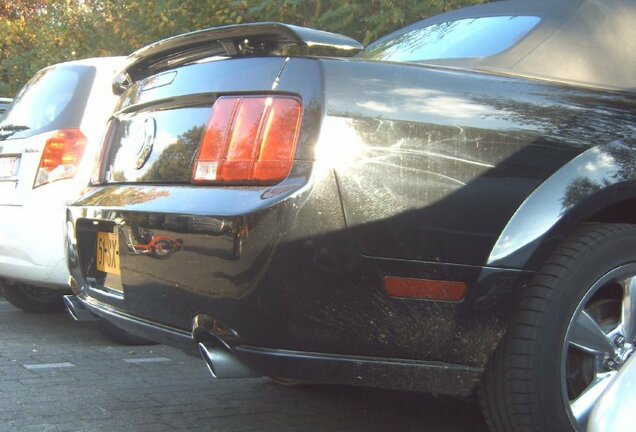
<box><xmin>361</xmin><ymin>0</ymin><xmax>636</xmax><ymax>92</ymax></box>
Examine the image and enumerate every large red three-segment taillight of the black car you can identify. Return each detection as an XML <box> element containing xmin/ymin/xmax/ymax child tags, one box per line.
<box><xmin>192</xmin><ymin>96</ymin><xmax>302</xmax><ymax>183</ymax></box>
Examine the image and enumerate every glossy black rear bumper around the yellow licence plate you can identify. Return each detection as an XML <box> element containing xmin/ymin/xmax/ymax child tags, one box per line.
<box><xmin>67</xmin><ymin>173</ymin><xmax>528</xmax><ymax>394</ymax></box>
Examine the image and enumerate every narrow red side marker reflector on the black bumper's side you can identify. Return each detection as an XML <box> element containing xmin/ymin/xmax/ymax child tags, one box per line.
<box><xmin>383</xmin><ymin>276</ymin><xmax>466</xmax><ymax>301</ymax></box>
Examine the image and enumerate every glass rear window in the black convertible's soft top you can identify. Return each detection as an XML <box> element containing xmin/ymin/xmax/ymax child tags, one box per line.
<box><xmin>358</xmin><ymin>16</ymin><xmax>540</xmax><ymax>62</ymax></box>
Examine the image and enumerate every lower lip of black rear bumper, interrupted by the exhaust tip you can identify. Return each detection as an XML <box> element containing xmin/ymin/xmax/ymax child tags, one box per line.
<box><xmin>67</xmin><ymin>294</ymin><xmax>483</xmax><ymax>396</ymax></box>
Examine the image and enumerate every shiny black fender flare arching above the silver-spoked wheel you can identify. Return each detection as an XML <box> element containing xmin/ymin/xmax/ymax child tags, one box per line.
<box><xmin>486</xmin><ymin>141</ymin><xmax>636</xmax><ymax>271</ymax></box>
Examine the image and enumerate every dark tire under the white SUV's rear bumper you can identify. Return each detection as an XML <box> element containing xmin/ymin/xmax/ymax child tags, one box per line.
<box><xmin>4</xmin><ymin>283</ymin><xmax>70</xmax><ymax>313</ymax></box>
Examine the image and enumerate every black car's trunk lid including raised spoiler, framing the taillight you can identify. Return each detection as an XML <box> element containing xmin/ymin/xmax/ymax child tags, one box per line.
<box><xmin>103</xmin><ymin>23</ymin><xmax>346</xmax><ymax>184</ymax></box>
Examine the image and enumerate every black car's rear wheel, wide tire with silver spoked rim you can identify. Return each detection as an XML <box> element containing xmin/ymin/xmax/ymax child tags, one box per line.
<box><xmin>478</xmin><ymin>224</ymin><xmax>636</xmax><ymax>432</ymax></box>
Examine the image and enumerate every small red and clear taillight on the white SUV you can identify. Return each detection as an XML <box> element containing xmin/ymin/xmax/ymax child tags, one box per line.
<box><xmin>33</xmin><ymin>129</ymin><xmax>86</xmax><ymax>188</ymax></box>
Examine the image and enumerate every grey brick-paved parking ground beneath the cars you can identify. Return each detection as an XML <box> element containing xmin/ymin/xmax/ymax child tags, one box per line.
<box><xmin>0</xmin><ymin>297</ymin><xmax>486</xmax><ymax>432</ymax></box>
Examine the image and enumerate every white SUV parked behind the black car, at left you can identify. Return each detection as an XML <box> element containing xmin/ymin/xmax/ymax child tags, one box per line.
<box><xmin>0</xmin><ymin>57</ymin><xmax>124</xmax><ymax>312</ymax></box>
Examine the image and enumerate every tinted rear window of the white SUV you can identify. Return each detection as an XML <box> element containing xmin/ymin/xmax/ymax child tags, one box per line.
<box><xmin>0</xmin><ymin>65</ymin><xmax>95</xmax><ymax>139</ymax></box>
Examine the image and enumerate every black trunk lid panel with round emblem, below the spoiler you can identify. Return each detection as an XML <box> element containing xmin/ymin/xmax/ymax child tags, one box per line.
<box><xmin>102</xmin><ymin>57</ymin><xmax>292</xmax><ymax>184</ymax></box>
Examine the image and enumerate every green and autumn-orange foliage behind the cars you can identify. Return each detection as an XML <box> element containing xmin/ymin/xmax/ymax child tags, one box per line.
<box><xmin>0</xmin><ymin>0</ymin><xmax>488</xmax><ymax>96</ymax></box>
